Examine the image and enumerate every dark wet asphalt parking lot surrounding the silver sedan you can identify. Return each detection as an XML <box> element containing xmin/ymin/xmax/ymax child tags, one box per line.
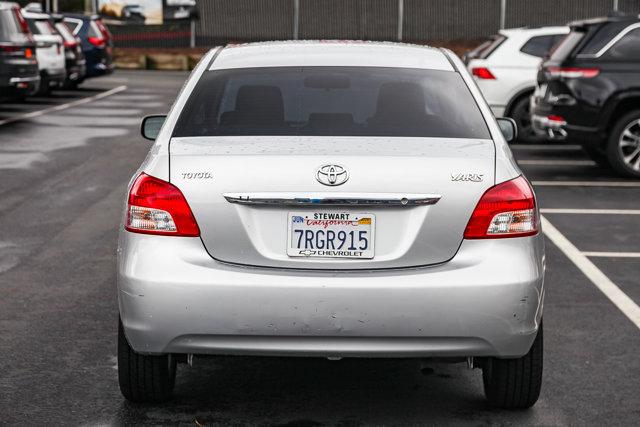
<box><xmin>0</xmin><ymin>72</ymin><xmax>640</xmax><ymax>426</ymax></box>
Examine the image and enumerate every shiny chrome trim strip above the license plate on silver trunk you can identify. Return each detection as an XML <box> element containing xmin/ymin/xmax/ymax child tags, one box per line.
<box><xmin>223</xmin><ymin>193</ymin><xmax>442</xmax><ymax>207</ymax></box>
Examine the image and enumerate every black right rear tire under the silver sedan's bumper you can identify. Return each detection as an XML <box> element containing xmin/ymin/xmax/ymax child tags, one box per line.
<box><xmin>482</xmin><ymin>323</ymin><xmax>543</xmax><ymax>409</ymax></box>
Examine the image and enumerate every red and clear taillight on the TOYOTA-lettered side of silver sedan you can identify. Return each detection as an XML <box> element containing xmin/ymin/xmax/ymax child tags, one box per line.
<box><xmin>125</xmin><ymin>173</ymin><xmax>200</xmax><ymax>237</ymax></box>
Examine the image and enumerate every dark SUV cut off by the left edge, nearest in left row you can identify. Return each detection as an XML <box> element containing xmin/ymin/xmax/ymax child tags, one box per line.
<box><xmin>0</xmin><ymin>2</ymin><xmax>40</xmax><ymax>98</ymax></box>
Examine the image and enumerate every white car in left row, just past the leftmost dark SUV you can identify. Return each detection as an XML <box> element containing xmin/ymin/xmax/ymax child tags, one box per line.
<box><xmin>22</xmin><ymin>9</ymin><xmax>67</xmax><ymax>95</ymax></box>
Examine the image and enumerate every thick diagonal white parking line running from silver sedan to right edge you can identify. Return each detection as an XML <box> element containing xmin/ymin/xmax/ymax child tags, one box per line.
<box><xmin>542</xmin><ymin>217</ymin><xmax>640</xmax><ymax>329</ymax></box>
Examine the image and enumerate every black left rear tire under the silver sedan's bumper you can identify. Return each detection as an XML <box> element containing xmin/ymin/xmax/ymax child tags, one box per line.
<box><xmin>118</xmin><ymin>321</ymin><xmax>176</xmax><ymax>403</ymax></box>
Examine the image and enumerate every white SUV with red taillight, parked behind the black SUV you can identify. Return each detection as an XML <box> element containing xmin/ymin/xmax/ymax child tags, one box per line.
<box><xmin>465</xmin><ymin>27</ymin><xmax>569</xmax><ymax>142</ymax></box>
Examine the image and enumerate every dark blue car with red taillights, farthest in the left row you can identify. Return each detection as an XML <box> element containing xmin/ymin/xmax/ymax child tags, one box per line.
<box><xmin>64</xmin><ymin>14</ymin><xmax>115</xmax><ymax>77</ymax></box>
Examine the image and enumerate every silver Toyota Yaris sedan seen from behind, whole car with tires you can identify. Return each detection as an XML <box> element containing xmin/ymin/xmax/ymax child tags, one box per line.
<box><xmin>118</xmin><ymin>42</ymin><xmax>544</xmax><ymax>408</ymax></box>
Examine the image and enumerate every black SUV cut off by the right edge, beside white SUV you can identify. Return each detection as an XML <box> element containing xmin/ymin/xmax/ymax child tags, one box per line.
<box><xmin>531</xmin><ymin>16</ymin><xmax>640</xmax><ymax>178</ymax></box>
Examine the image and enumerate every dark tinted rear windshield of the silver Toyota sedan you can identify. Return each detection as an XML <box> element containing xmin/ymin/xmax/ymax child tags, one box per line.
<box><xmin>173</xmin><ymin>67</ymin><xmax>490</xmax><ymax>139</ymax></box>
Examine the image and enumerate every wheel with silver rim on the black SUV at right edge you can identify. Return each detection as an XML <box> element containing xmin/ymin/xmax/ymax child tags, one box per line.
<box><xmin>606</xmin><ymin>110</ymin><xmax>640</xmax><ymax>178</ymax></box>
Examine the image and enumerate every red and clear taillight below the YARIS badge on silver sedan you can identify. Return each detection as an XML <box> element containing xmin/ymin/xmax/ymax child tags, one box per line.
<box><xmin>464</xmin><ymin>176</ymin><xmax>539</xmax><ymax>239</ymax></box>
